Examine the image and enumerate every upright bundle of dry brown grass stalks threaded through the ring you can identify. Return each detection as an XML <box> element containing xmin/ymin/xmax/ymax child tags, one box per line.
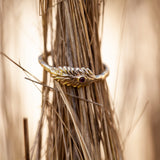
<box><xmin>32</xmin><ymin>0</ymin><xmax>123</xmax><ymax>160</ymax></box>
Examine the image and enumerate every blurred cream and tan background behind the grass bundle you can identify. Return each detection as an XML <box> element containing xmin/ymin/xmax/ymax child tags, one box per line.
<box><xmin>0</xmin><ymin>0</ymin><xmax>160</xmax><ymax>160</ymax></box>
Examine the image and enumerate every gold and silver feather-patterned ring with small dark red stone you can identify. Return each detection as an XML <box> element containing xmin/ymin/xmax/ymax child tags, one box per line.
<box><xmin>38</xmin><ymin>54</ymin><xmax>109</xmax><ymax>88</ymax></box>
